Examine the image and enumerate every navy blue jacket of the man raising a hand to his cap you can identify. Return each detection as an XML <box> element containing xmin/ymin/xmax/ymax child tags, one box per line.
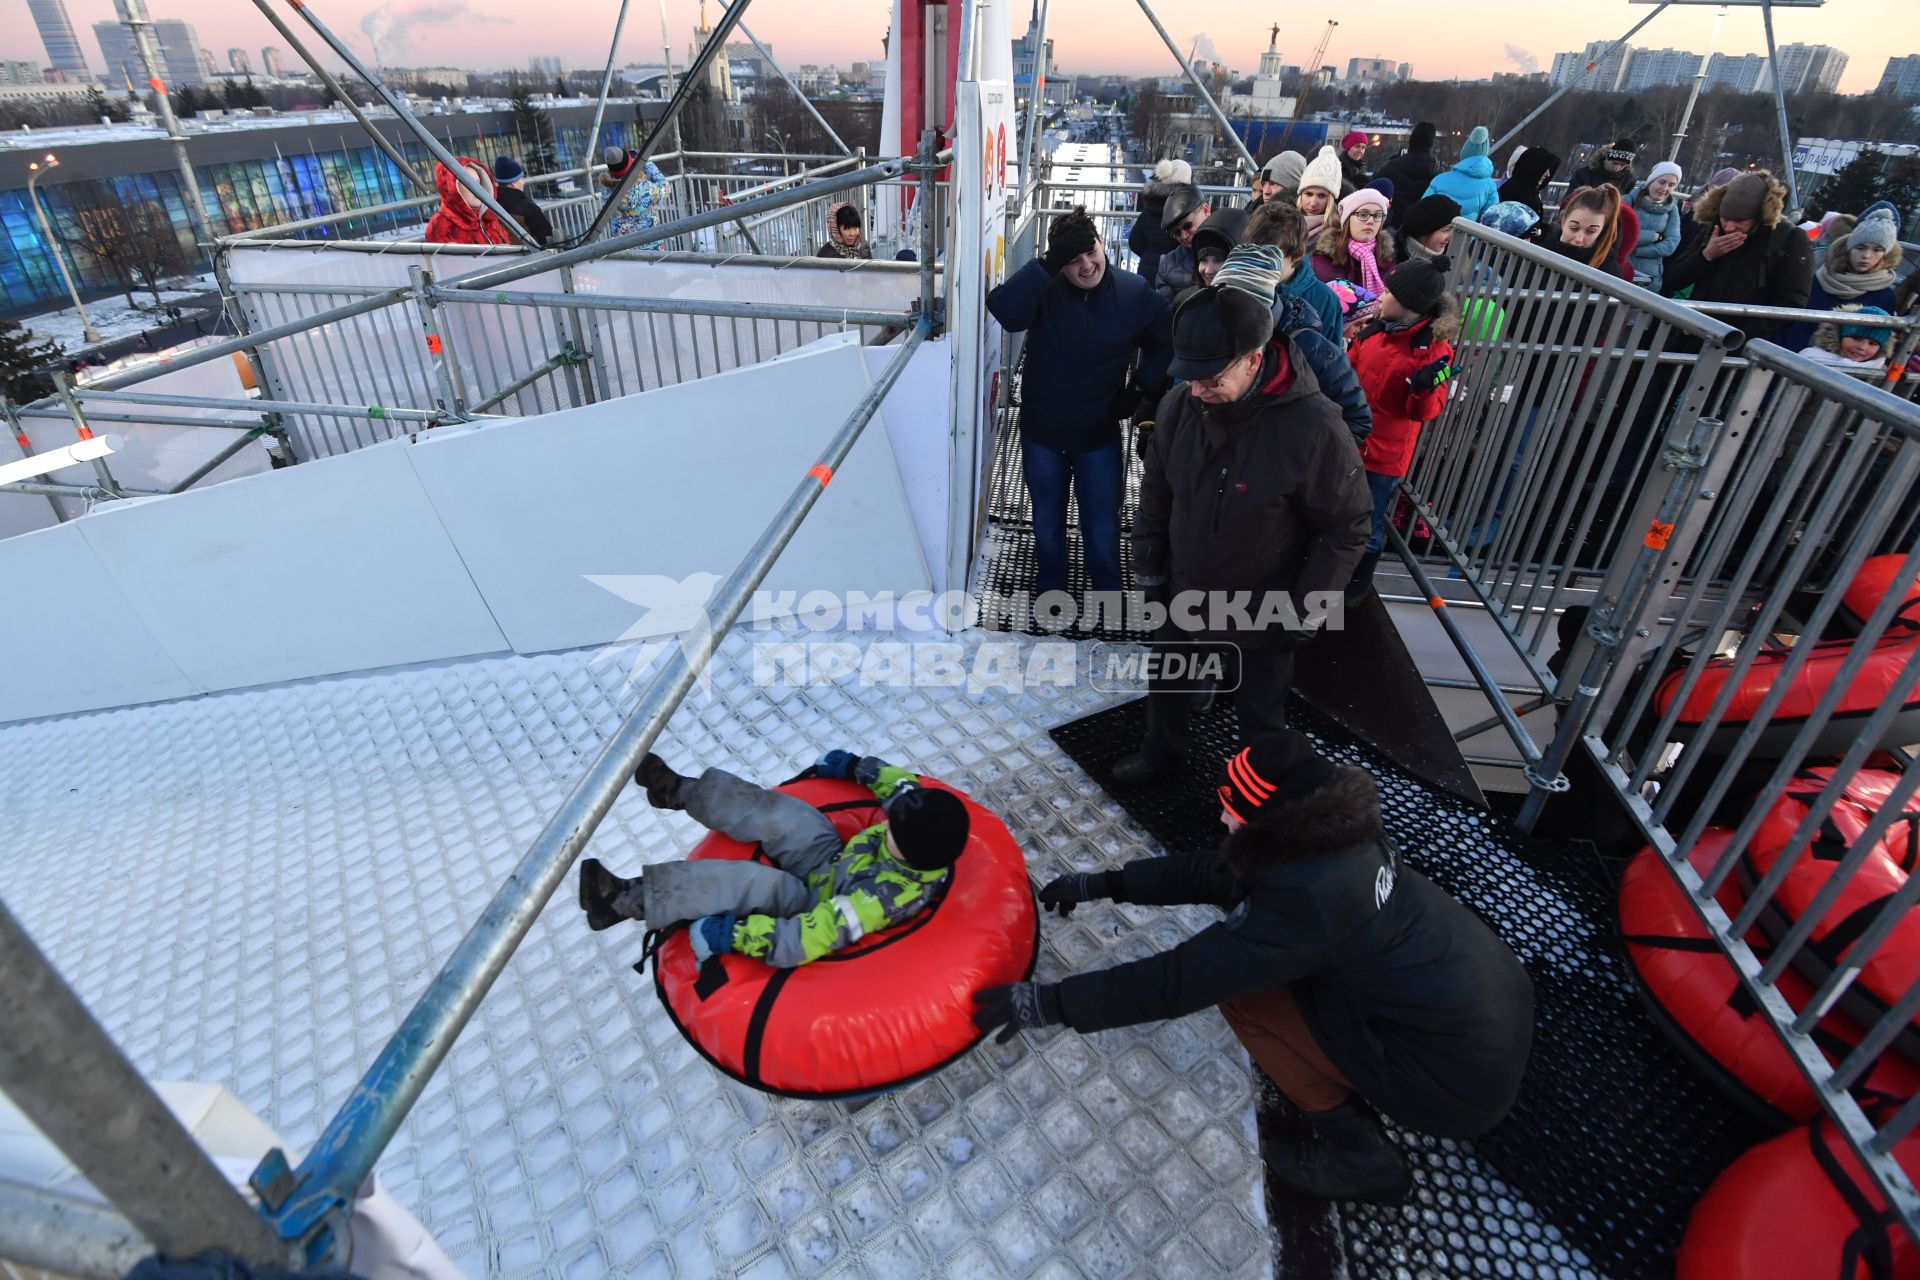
<box><xmin>987</xmin><ymin>259</ymin><xmax>1173</xmax><ymax>453</ymax></box>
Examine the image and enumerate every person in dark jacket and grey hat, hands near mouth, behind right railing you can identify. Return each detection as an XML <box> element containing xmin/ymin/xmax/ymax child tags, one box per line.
<box><xmin>1661</xmin><ymin>169</ymin><xmax>1812</xmax><ymax>338</ymax></box>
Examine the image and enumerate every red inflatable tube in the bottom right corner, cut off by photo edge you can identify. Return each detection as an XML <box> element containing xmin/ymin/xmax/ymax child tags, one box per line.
<box><xmin>1674</xmin><ymin>1117</ymin><xmax>1920</xmax><ymax>1280</ymax></box>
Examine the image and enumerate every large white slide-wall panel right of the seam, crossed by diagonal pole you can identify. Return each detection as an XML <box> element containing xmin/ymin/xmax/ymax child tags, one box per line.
<box><xmin>411</xmin><ymin>340</ymin><xmax>929</xmax><ymax>652</ymax></box>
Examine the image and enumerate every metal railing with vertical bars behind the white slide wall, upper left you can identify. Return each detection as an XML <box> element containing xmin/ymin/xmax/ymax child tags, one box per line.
<box><xmin>0</xmin><ymin>155</ymin><xmax>943</xmax><ymax>518</ymax></box>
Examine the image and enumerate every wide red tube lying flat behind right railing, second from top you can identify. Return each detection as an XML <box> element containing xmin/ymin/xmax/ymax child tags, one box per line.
<box><xmin>1653</xmin><ymin>628</ymin><xmax>1920</xmax><ymax>760</ymax></box>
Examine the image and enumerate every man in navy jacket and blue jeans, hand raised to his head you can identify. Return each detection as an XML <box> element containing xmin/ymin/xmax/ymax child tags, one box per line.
<box><xmin>987</xmin><ymin>209</ymin><xmax>1171</xmax><ymax>591</ymax></box>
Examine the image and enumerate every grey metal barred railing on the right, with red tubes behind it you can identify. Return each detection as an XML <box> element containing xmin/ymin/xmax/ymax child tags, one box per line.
<box><xmin>1392</xmin><ymin>221</ymin><xmax>1920</xmax><ymax>1234</ymax></box>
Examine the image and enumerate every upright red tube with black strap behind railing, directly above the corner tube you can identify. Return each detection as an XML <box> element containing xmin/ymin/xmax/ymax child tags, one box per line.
<box><xmin>1620</xmin><ymin>827</ymin><xmax>1920</xmax><ymax>1126</ymax></box>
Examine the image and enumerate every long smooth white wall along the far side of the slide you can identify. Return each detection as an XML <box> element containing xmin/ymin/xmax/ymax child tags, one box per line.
<box><xmin>0</xmin><ymin>336</ymin><xmax>947</xmax><ymax>722</ymax></box>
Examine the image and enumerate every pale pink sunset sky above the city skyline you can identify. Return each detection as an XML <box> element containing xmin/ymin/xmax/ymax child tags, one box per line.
<box><xmin>0</xmin><ymin>0</ymin><xmax>1920</xmax><ymax>92</ymax></box>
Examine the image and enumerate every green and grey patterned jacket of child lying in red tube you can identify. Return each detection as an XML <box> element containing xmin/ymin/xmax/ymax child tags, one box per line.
<box><xmin>733</xmin><ymin>756</ymin><xmax>947</xmax><ymax>969</ymax></box>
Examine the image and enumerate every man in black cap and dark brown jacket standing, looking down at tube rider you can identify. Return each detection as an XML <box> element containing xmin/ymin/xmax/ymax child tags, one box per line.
<box><xmin>1114</xmin><ymin>244</ymin><xmax>1373</xmax><ymax>783</ymax></box>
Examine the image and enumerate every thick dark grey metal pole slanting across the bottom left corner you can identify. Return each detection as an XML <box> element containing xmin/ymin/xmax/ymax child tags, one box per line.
<box><xmin>0</xmin><ymin>902</ymin><xmax>288</xmax><ymax>1267</ymax></box>
